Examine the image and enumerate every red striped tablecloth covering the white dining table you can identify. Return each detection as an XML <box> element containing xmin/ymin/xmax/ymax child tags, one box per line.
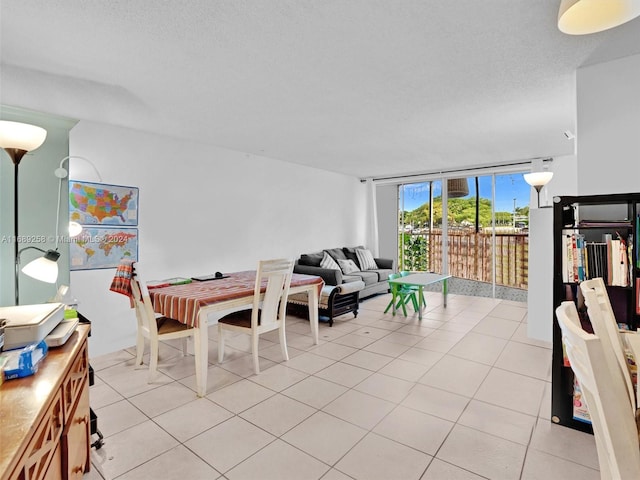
<box><xmin>149</xmin><ymin>270</ymin><xmax>324</xmax><ymax>327</ymax></box>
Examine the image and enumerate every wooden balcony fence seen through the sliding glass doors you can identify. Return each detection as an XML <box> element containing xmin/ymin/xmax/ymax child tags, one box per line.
<box><xmin>401</xmin><ymin>230</ymin><xmax>529</xmax><ymax>289</ymax></box>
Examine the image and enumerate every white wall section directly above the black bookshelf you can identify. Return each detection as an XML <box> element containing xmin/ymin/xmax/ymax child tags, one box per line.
<box><xmin>576</xmin><ymin>55</ymin><xmax>640</xmax><ymax>195</ymax></box>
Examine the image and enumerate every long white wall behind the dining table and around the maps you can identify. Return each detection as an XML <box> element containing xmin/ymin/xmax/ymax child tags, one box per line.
<box><xmin>69</xmin><ymin>121</ymin><xmax>366</xmax><ymax>356</ymax></box>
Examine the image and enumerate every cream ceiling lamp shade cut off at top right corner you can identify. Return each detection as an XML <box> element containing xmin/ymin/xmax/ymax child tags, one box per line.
<box><xmin>558</xmin><ymin>0</ymin><xmax>640</xmax><ymax>35</ymax></box>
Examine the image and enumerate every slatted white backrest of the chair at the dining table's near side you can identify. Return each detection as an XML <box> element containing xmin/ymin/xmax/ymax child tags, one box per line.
<box><xmin>251</xmin><ymin>258</ymin><xmax>294</xmax><ymax>328</ymax></box>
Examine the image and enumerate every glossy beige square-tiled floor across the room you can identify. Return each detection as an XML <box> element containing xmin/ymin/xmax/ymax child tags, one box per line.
<box><xmin>85</xmin><ymin>293</ymin><xmax>600</xmax><ymax>480</ymax></box>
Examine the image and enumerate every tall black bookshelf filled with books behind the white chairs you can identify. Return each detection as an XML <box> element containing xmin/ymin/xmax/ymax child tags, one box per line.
<box><xmin>551</xmin><ymin>193</ymin><xmax>640</xmax><ymax>433</ymax></box>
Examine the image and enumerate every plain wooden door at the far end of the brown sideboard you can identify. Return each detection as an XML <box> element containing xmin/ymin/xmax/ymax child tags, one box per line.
<box><xmin>61</xmin><ymin>380</ymin><xmax>90</xmax><ymax>479</ymax></box>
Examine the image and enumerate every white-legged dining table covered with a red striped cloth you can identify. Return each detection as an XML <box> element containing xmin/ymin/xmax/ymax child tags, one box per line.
<box><xmin>149</xmin><ymin>270</ymin><xmax>324</xmax><ymax>397</ymax></box>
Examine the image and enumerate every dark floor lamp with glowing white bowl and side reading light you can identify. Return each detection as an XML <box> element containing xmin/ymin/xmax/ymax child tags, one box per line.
<box><xmin>0</xmin><ymin>120</ymin><xmax>52</xmax><ymax>305</ymax></box>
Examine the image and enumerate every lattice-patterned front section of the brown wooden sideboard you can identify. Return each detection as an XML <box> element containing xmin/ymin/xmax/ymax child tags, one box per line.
<box><xmin>9</xmin><ymin>391</ymin><xmax>63</xmax><ymax>480</ymax></box>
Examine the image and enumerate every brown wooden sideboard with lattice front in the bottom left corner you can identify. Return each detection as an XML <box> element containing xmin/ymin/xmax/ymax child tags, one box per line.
<box><xmin>0</xmin><ymin>325</ymin><xmax>91</xmax><ymax>480</ymax></box>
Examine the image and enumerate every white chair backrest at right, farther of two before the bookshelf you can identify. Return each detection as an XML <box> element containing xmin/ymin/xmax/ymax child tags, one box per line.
<box><xmin>580</xmin><ymin>278</ymin><xmax>636</xmax><ymax>412</ymax></box>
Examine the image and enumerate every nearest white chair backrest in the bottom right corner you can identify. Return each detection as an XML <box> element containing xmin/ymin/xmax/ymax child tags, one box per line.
<box><xmin>556</xmin><ymin>302</ymin><xmax>640</xmax><ymax>480</ymax></box>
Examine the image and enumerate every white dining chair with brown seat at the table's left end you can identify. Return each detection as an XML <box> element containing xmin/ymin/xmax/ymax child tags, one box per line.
<box><xmin>131</xmin><ymin>263</ymin><xmax>195</xmax><ymax>382</ymax></box>
